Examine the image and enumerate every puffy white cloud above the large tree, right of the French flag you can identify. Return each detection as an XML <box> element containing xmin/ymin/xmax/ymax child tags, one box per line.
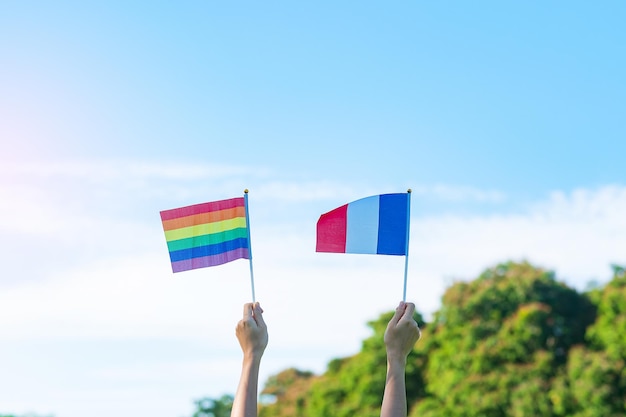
<box><xmin>412</xmin><ymin>186</ymin><xmax>626</xmax><ymax>289</ymax></box>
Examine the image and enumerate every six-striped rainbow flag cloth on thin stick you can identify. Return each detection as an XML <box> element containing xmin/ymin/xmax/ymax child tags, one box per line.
<box><xmin>161</xmin><ymin>197</ymin><xmax>251</xmax><ymax>272</ymax></box>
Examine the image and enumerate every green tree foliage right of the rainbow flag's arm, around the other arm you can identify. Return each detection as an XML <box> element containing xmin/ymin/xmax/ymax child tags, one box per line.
<box><xmin>254</xmin><ymin>262</ymin><xmax>626</xmax><ymax>417</ymax></box>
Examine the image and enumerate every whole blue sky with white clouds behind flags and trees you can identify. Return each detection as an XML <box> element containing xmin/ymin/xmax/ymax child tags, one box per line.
<box><xmin>0</xmin><ymin>1</ymin><xmax>626</xmax><ymax>417</ymax></box>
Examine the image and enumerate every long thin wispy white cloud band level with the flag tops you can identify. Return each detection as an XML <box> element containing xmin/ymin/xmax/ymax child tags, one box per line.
<box><xmin>0</xmin><ymin>159</ymin><xmax>506</xmax><ymax>212</ymax></box>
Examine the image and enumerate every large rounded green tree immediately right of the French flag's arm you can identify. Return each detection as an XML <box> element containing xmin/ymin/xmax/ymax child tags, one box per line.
<box><xmin>411</xmin><ymin>262</ymin><xmax>595</xmax><ymax>417</ymax></box>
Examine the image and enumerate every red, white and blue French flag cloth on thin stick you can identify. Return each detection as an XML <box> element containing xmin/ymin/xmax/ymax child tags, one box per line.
<box><xmin>316</xmin><ymin>193</ymin><xmax>410</xmax><ymax>255</ymax></box>
